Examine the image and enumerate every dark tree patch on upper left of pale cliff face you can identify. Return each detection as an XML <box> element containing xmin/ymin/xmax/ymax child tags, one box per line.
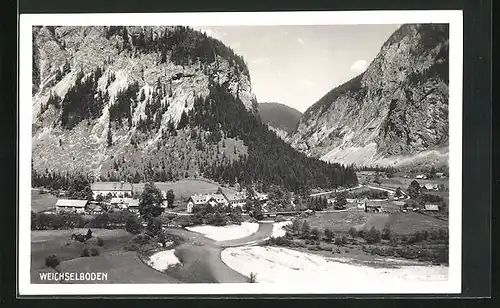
<box><xmin>60</xmin><ymin>67</ymin><xmax>109</xmax><ymax>129</ymax></box>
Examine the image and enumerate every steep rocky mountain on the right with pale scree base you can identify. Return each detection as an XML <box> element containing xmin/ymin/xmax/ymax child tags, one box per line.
<box><xmin>289</xmin><ymin>24</ymin><xmax>449</xmax><ymax>167</ymax></box>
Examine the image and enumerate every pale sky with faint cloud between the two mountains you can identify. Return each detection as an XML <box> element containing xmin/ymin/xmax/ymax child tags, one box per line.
<box><xmin>195</xmin><ymin>24</ymin><xmax>400</xmax><ymax>112</ymax></box>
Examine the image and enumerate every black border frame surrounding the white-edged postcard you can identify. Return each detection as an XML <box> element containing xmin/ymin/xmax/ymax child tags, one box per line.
<box><xmin>0</xmin><ymin>0</ymin><xmax>492</xmax><ymax>305</ymax></box>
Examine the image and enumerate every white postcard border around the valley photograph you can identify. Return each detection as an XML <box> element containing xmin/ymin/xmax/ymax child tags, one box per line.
<box><xmin>17</xmin><ymin>11</ymin><xmax>463</xmax><ymax>295</ymax></box>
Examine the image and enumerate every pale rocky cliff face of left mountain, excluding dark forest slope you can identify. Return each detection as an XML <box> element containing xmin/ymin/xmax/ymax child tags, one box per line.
<box><xmin>32</xmin><ymin>27</ymin><xmax>257</xmax><ymax>175</ymax></box>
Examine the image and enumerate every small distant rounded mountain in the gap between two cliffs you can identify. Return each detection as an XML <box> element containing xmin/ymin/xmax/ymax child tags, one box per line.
<box><xmin>259</xmin><ymin>103</ymin><xmax>302</xmax><ymax>139</ymax></box>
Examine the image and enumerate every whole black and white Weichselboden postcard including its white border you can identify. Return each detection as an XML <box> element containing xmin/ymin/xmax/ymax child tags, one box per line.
<box><xmin>19</xmin><ymin>11</ymin><xmax>462</xmax><ymax>295</ymax></box>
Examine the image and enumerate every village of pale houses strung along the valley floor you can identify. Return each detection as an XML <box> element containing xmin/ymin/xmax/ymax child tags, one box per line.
<box><xmin>34</xmin><ymin>171</ymin><xmax>445</xmax><ymax>224</ymax></box>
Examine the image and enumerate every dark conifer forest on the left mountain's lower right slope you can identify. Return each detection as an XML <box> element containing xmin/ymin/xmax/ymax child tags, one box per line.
<box><xmin>186</xmin><ymin>81</ymin><xmax>358</xmax><ymax>192</ymax></box>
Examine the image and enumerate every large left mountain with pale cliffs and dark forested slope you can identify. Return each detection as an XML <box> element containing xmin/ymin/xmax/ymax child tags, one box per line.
<box><xmin>32</xmin><ymin>26</ymin><xmax>357</xmax><ymax>191</ymax></box>
